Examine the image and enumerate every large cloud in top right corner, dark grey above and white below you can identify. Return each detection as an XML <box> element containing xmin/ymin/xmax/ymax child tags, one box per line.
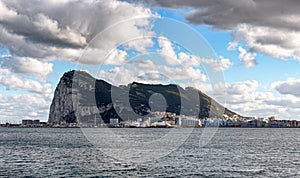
<box><xmin>146</xmin><ymin>0</ymin><xmax>300</xmax><ymax>60</ymax></box>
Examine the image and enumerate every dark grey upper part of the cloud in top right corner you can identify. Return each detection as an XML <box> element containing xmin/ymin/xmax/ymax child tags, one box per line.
<box><xmin>148</xmin><ymin>0</ymin><xmax>300</xmax><ymax>30</ymax></box>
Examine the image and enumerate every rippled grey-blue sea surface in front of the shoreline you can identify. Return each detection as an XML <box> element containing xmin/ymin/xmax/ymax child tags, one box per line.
<box><xmin>0</xmin><ymin>128</ymin><xmax>300</xmax><ymax>177</ymax></box>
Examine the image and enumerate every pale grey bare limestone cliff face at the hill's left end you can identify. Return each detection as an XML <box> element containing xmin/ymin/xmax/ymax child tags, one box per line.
<box><xmin>48</xmin><ymin>70</ymin><xmax>99</xmax><ymax>123</ymax></box>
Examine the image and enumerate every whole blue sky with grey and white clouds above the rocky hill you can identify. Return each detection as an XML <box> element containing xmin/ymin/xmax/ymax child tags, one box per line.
<box><xmin>0</xmin><ymin>0</ymin><xmax>300</xmax><ymax>123</ymax></box>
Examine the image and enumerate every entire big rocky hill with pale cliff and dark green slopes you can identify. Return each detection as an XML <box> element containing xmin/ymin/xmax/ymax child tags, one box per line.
<box><xmin>48</xmin><ymin>70</ymin><xmax>241</xmax><ymax>123</ymax></box>
